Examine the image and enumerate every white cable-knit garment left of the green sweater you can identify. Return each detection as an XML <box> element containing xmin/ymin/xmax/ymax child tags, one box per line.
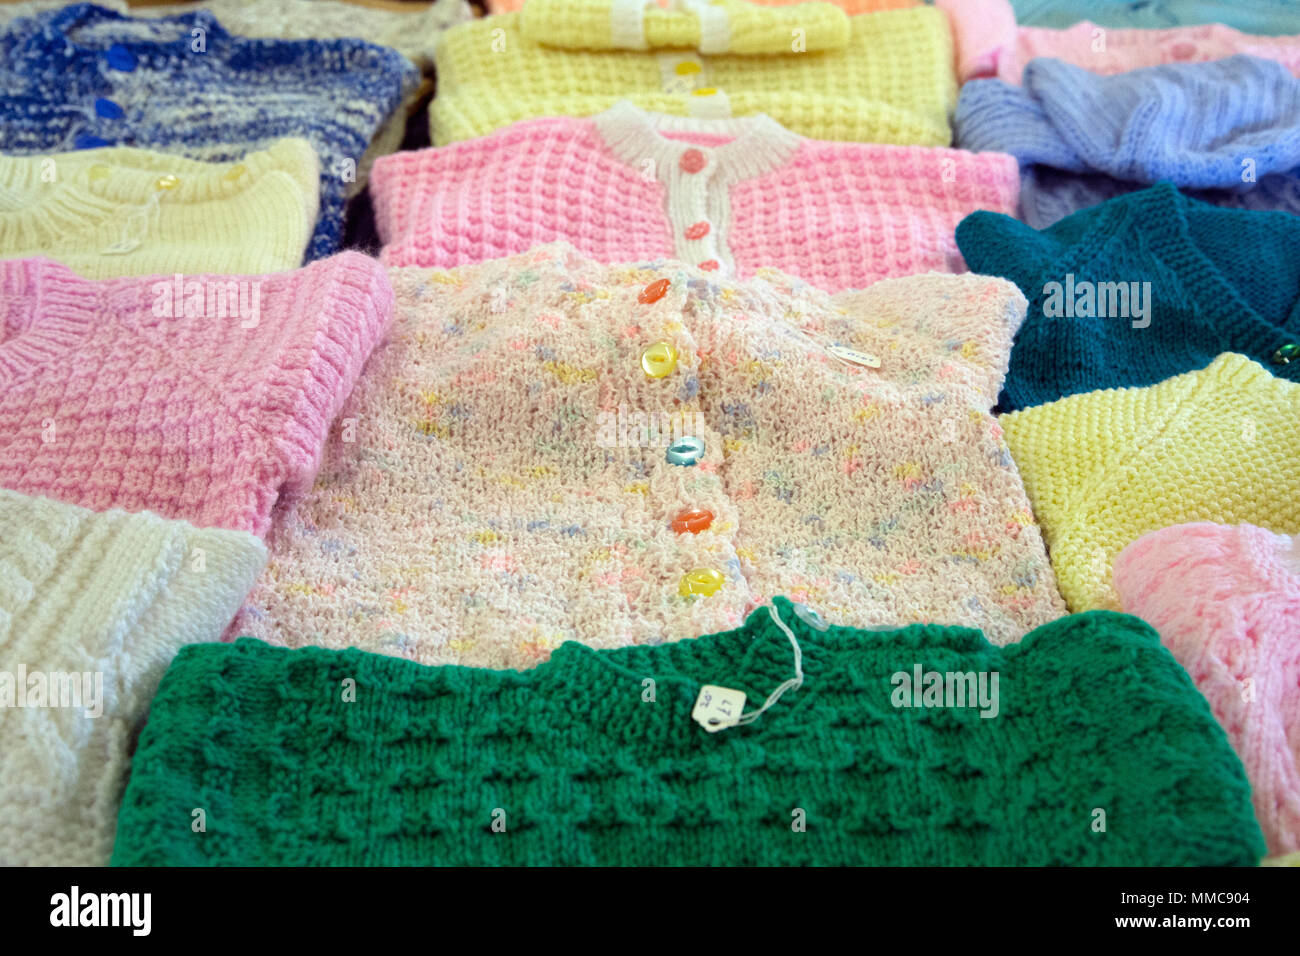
<box><xmin>0</xmin><ymin>490</ymin><xmax>267</xmax><ymax>866</ymax></box>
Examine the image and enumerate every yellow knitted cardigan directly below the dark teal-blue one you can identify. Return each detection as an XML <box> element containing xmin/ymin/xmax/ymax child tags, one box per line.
<box><xmin>1001</xmin><ymin>354</ymin><xmax>1300</xmax><ymax>611</ymax></box>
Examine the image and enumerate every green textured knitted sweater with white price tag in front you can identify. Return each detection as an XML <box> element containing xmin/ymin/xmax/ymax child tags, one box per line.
<box><xmin>113</xmin><ymin>598</ymin><xmax>1264</xmax><ymax>866</ymax></box>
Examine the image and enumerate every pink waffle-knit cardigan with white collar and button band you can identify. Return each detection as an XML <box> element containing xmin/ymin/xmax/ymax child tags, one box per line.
<box><xmin>371</xmin><ymin>101</ymin><xmax>1019</xmax><ymax>291</ymax></box>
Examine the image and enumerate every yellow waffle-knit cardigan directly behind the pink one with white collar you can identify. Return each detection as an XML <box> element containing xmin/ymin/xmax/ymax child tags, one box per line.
<box><xmin>429</xmin><ymin>7</ymin><xmax>957</xmax><ymax>146</ymax></box>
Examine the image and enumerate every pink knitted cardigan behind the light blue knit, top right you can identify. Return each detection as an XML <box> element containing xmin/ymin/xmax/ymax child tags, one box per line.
<box><xmin>935</xmin><ymin>0</ymin><xmax>1300</xmax><ymax>83</ymax></box>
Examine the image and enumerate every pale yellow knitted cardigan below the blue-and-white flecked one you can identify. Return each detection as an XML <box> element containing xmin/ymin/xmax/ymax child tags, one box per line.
<box><xmin>0</xmin><ymin>139</ymin><xmax>320</xmax><ymax>278</ymax></box>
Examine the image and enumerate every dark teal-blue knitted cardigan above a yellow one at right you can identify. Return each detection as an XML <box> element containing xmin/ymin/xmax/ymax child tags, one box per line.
<box><xmin>957</xmin><ymin>182</ymin><xmax>1300</xmax><ymax>411</ymax></box>
